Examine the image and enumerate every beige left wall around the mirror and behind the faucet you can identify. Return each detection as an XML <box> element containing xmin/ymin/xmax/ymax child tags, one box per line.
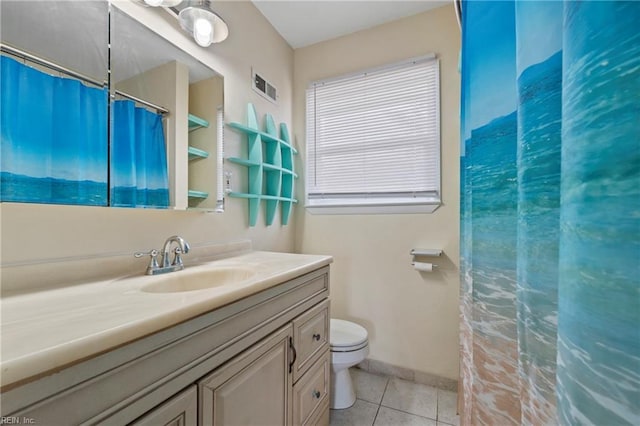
<box><xmin>0</xmin><ymin>1</ymin><xmax>295</xmax><ymax>264</ymax></box>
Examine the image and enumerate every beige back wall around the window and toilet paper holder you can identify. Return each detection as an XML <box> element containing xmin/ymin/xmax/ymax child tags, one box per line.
<box><xmin>293</xmin><ymin>6</ymin><xmax>460</xmax><ymax>379</ymax></box>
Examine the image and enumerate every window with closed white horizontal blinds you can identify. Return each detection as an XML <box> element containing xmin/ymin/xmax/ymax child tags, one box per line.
<box><xmin>306</xmin><ymin>55</ymin><xmax>440</xmax><ymax>213</ymax></box>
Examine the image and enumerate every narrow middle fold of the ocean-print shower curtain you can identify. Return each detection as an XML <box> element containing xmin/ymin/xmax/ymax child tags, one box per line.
<box><xmin>515</xmin><ymin>1</ymin><xmax>563</xmax><ymax>423</ymax></box>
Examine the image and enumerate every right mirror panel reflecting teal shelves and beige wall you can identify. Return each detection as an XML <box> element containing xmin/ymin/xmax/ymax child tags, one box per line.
<box><xmin>111</xmin><ymin>3</ymin><xmax>224</xmax><ymax>211</ymax></box>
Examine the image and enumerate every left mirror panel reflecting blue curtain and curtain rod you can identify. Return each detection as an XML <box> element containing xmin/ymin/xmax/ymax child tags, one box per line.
<box><xmin>0</xmin><ymin>0</ymin><xmax>109</xmax><ymax>206</ymax></box>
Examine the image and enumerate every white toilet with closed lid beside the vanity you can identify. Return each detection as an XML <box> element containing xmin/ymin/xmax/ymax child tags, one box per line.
<box><xmin>329</xmin><ymin>318</ymin><xmax>369</xmax><ymax>409</ymax></box>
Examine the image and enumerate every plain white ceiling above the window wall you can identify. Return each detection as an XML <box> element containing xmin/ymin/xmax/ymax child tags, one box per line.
<box><xmin>252</xmin><ymin>0</ymin><xmax>453</xmax><ymax>49</ymax></box>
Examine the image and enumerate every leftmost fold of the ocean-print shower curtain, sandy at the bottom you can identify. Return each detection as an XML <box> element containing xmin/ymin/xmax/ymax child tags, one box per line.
<box><xmin>461</xmin><ymin>2</ymin><xmax>521</xmax><ymax>424</ymax></box>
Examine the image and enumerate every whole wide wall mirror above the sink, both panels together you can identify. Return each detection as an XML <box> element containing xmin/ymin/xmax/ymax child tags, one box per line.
<box><xmin>0</xmin><ymin>0</ymin><xmax>224</xmax><ymax>211</ymax></box>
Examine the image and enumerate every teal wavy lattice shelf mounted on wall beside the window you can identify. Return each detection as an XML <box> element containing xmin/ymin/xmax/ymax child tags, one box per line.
<box><xmin>227</xmin><ymin>104</ymin><xmax>298</xmax><ymax>226</ymax></box>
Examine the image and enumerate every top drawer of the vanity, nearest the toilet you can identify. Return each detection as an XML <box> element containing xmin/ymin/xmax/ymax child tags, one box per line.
<box><xmin>293</xmin><ymin>301</ymin><xmax>329</xmax><ymax>382</ymax></box>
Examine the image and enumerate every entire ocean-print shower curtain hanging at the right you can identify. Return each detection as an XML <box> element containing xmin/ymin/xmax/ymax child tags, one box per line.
<box><xmin>460</xmin><ymin>1</ymin><xmax>640</xmax><ymax>425</ymax></box>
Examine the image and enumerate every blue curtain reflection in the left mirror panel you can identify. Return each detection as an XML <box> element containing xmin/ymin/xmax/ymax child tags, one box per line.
<box><xmin>0</xmin><ymin>56</ymin><xmax>108</xmax><ymax>206</ymax></box>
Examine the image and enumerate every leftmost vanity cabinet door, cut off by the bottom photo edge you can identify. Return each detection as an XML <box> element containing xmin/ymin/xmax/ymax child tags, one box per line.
<box><xmin>131</xmin><ymin>385</ymin><xmax>198</xmax><ymax>426</ymax></box>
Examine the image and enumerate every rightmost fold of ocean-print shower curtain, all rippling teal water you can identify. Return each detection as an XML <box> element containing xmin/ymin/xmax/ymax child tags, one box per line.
<box><xmin>557</xmin><ymin>1</ymin><xmax>640</xmax><ymax>425</ymax></box>
